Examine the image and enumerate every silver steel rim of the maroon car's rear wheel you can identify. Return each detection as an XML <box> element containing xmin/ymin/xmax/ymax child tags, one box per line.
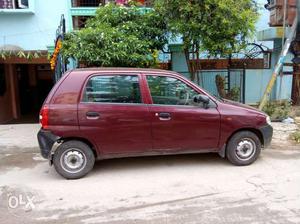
<box><xmin>60</xmin><ymin>148</ymin><xmax>86</xmax><ymax>173</ymax></box>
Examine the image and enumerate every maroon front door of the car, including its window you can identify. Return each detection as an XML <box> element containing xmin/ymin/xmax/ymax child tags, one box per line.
<box><xmin>146</xmin><ymin>75</ymin><xmax>220</xmax><ymax>153</ymax></box>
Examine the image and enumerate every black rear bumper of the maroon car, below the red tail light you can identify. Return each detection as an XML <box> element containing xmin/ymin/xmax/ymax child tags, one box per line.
<box><xmin>37</xmin><ymin>129</ymin><xmax>60</xmax><ymax>159</ymax></box>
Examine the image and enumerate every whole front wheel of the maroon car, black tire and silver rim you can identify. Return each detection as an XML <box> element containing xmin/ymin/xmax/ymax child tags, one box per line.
<box><xmin>226</xmin><ymin>131</ymin><xmax>261</xmax><ymax>166</ymax></box>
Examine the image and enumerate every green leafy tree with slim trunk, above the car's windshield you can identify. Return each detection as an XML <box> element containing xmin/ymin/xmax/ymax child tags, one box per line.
<box><xmin>155</xmin><ymin>0</ymin><xmax>258</xmax><ymax>80</ymax></box>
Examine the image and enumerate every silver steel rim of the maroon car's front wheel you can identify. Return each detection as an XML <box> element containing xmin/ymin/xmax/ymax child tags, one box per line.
<box><xmin>236</xmin><ymin>138</ymin><xmax>256</xmax><ymax>160</ymax></box>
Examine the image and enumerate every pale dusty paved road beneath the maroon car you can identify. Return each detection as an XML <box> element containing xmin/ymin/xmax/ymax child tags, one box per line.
<box><xmin>0</xmin><ymin>146</ymin><xmax>300</xmax><ymax>224</ymax></box>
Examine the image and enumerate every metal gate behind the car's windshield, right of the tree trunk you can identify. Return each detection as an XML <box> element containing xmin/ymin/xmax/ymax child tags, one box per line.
<box><xmin>198</xmin><ymin>69</ymin><xmax>245</xmax><ymax>103</ymax></box>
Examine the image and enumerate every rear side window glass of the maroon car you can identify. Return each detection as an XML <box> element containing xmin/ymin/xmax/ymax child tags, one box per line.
<box><xmin>83</xmin><ymin>75</ymin><xmax>141</xmax><ymax>103</ymax></box>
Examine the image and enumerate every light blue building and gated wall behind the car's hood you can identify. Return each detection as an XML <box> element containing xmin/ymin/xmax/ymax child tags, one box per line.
<box><xmin>170</xmin><ymin>0</ymin><xmax>296</xmax><ymax>105</ymax></box>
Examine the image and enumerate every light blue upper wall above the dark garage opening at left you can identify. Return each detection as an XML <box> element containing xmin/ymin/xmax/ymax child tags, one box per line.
<box><xmin>0</xmin><ymin>0</ymin><xmax>70</xmax><ymax>50</ymax></box>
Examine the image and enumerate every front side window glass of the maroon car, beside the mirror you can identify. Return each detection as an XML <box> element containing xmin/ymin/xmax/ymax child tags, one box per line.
<box><xmin>147</xmin><ymin>76</ymin><xmax>198</xmax><ymax>105</ymax></box>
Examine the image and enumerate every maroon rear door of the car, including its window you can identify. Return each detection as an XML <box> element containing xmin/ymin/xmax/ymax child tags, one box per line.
<box><xmin>78</xmin><ymin>74</ymin><xmax>152</xmax><ymax>157</ymax></box>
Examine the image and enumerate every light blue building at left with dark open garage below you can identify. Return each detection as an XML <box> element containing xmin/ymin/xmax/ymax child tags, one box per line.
<box><xmin>0</xmin><ymin>0</ymin><xmax>68</xmax><ymax>123</ymax></box>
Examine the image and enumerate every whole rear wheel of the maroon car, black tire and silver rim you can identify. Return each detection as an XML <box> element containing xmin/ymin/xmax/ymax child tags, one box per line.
<box><xmin>53</xmin><ymin>140</ymin><xmax>95</xmax><ymax>179</ymax></box>
